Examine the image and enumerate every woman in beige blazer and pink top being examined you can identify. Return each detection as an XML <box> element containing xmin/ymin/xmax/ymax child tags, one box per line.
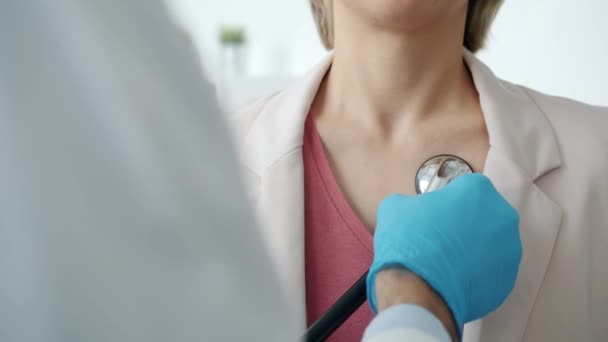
<box><xmin>230</xmin><ymin>0</ymin><xmax>608</xmax><ymax>341</ymax></box>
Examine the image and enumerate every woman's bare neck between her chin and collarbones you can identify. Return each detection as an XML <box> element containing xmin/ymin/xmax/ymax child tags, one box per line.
<box><xmin>315</xmin><ymin>2</ymin><xmax>477</xmax><ymax>133</ymax></box>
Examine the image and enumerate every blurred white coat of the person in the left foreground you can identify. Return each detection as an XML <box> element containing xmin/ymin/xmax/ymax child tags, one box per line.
<box><xmin>0</xmin><ymin>0</ymin><xmax>294</xmax><ymax>342</ymax></box>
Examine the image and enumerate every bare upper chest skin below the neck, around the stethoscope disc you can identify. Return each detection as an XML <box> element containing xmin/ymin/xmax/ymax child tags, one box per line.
<box><xmin>316</xmin><ymin>110</ymin><xmax>489</xmax><ymax>232</ymax></box>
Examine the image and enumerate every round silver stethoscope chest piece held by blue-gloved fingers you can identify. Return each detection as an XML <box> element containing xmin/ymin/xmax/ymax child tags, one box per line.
<box><xmin>415</xmin><ymin>154</ymin><xmax>473</xmax><ymax>195</ymax></box>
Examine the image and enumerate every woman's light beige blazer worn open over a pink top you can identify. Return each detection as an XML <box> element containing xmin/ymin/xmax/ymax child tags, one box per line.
<box><xmin>235</xmin><ymin>51</ymin><xmax>608</xmax><ymax>342</ymax></box>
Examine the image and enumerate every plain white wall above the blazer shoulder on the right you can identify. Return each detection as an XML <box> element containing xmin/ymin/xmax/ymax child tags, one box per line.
<box><xmin>479</xmin><ymin>0</ymin><xmax>608</xmax><ymax>106</ymax></box>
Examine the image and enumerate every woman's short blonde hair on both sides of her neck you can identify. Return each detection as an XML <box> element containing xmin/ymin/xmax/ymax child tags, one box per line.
<box><xmin>309</xmin><ymin>0</ymin><xmax>503</xmax><ymax>52</ymax></box>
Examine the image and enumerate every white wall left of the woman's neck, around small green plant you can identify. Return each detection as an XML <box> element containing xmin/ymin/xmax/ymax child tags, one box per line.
<box><xmin>169</xmin><ymin>0</ymin><xmax>324</xmax><ymax>77</ymax></box>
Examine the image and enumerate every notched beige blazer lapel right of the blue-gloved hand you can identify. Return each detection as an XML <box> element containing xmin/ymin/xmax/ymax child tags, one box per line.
<box><xmin>463</xmin><ymin>51</ymin><xmax>562</xmax><ymax>342</ymax></box>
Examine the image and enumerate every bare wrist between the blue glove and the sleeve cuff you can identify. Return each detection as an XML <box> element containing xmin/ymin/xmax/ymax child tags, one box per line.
<box><xmin>375</xmin><ymin>268</ymin><xmax>458</xmax><ymax>341</ymax></box>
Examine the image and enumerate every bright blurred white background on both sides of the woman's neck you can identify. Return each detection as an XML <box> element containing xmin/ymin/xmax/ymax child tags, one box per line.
<box><xmin>167</xmin><ymin>0</ymin><xmax>608</xmax><ymax>109</ymax></box>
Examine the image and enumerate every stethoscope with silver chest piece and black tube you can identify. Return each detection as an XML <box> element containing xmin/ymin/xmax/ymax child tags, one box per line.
<box><xmin>303</xmin><ymin>154</ymin><xmax>474</xmax><ymax>342</ymax></box>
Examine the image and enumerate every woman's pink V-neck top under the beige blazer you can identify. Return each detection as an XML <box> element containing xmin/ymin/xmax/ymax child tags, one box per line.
<box><xmin>303</xmin><ymin>115</ymin><xmax>373</xmax><ymax>342</ymax></box>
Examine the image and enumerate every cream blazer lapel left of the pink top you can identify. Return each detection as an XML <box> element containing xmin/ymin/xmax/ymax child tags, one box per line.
<box><xmin>242</xmin><ymin>55</ymin><xmax>332</xmax><ymax>332</ymax></box>
